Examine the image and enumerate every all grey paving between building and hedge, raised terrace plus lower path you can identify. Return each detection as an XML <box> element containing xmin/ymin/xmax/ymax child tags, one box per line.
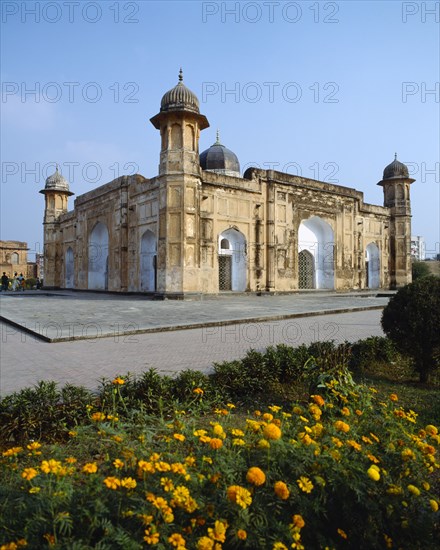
<box><xmin>0</xmin><ymin>293</ymin><xmax>388</xmax><ymax>396</ymax></box>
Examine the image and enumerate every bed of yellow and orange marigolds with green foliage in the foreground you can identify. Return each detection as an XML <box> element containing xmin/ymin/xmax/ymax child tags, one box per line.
<box><xmin>0</xmin><ymin>384</ymin><xmax>440</xmax><ymax>550</ymax></box>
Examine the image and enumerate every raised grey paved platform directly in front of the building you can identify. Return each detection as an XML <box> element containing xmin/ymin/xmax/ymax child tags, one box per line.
<box><xmin>0</xmin><ymin>291</ymin><xmax>389</xmax><ymax>342</ymax></box>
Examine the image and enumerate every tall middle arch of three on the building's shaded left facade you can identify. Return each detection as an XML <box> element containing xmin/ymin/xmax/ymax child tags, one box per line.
<box><xmin>88</xmin><ymin>222</ymin><xmax>108</xmax><ymax>290</ymax></box>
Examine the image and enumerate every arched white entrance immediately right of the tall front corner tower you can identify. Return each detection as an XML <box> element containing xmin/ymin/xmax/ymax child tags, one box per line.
<box><xmin>218</xmin><ymin>228</ymin><xmax>247</xmax><ymax>292</ymax></box>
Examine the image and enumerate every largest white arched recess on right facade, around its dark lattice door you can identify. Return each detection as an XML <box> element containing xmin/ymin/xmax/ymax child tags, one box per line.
<box><xmin>298</xmin><ymin>216</ymin><xmax>335</xmax><ymax>289</ymax></box>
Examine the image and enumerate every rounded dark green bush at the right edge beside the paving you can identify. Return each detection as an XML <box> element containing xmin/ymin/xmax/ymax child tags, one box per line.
<box><xmin>382</xmin><ymin>275</ymin><xmax>440</xmax><ymax>382</ymax></box>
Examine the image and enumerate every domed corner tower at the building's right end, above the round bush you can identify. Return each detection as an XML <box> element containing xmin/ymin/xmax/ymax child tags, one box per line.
<box><xmin>377</xmin><ymin>153</ymin><xmax>415</xmax><ymax>289</ymax></box>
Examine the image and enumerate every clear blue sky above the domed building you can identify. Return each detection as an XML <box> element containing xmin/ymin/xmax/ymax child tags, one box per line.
<box><xmin>0</xmin><ymin>0</ymin><xmax>440</xmax><ymax>255</ymax></box>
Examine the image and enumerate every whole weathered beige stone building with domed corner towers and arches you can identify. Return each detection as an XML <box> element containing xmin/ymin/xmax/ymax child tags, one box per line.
<box><xmin>40</xmin><ymin>74</ymin><xmax>414</xmax><ymax>298</ymax></box>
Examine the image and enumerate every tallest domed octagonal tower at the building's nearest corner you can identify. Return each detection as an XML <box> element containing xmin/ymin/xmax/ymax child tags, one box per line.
<box><xmin>151</xmin><ymin>69</ymin><xmax>209</xmax><ymax>298</ymax></box>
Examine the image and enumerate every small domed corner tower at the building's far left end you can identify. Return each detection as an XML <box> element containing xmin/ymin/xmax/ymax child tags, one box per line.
<box><xmin>40</xmin><ymin>165</ymin><xmax>74</xmax><ymax>288</ymax></box>
